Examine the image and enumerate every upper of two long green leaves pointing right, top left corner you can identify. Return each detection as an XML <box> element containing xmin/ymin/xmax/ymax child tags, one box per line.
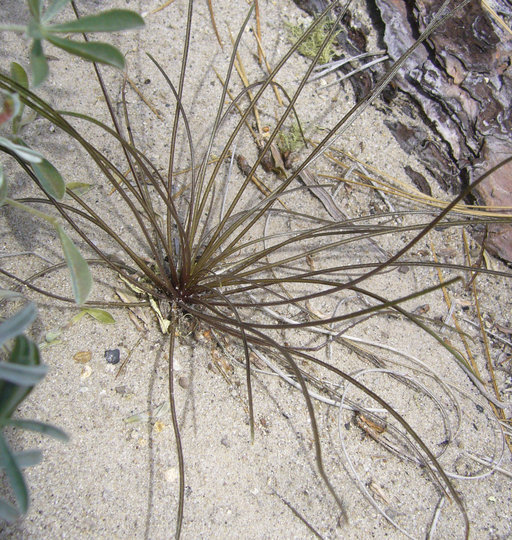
<box><xmin>45</xmin><ymin>9</ymin><xmax>144</xmax><ymax>33</ymax></box>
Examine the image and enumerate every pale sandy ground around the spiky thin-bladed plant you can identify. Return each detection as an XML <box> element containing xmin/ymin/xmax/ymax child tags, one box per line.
<box><xmin>0</xmin><ymin>0</ymin><xmax>512</xmax><ymax>539</ymax></box>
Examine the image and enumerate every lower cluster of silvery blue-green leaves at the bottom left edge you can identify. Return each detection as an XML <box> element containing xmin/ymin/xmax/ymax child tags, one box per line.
<box><xmin>0</xmin><ymin>290</ymin><xmax>67</xmax><ymax>522</ymax></box>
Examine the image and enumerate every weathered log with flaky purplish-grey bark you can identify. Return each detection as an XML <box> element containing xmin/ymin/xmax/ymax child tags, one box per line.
<box><xmin>297</xmin><ymin>0</ymin><xmax>512</xmax><ymax>261</ymax></box>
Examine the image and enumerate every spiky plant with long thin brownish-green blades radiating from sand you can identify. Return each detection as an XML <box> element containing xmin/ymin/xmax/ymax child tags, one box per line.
<box><xmin>0</xmin><ymin>1</ymin><xmax>510</xmax><ymax>537</ymax></box>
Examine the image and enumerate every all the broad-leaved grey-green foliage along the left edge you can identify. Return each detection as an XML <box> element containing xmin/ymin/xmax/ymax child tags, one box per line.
<box><xmin>0</xmin><ymin>0</ymin><xmax>144</xmax><ymax>521</ymax></box>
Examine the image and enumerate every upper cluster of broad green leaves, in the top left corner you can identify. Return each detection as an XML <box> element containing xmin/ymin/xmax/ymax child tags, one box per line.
<box><xmin>0</xmin><ymin>0</ymin><xmax>144</xmax><ymax>304</ymax></box>
